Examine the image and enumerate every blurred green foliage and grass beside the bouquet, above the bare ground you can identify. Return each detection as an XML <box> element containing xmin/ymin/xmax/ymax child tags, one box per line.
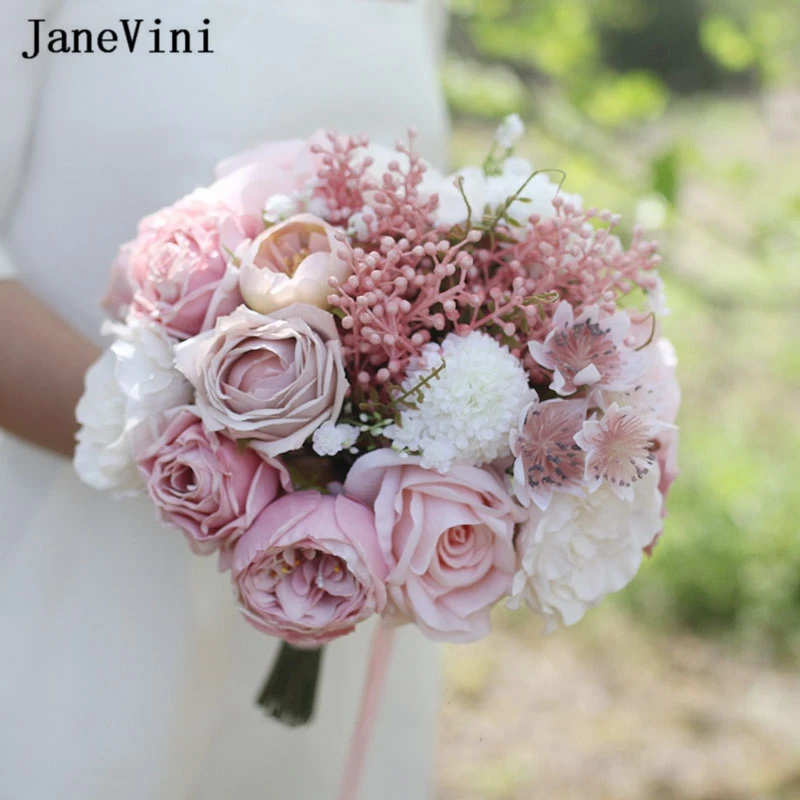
<box><xmin>445</xmin><ymin>0</ymin><xmax>800</xmax><ymax>658</ymax></box>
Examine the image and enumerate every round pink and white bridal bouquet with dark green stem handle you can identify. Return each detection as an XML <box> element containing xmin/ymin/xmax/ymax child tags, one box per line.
<box><xmin>75</xmin><ymin>118</ymin><xmax>679</xmax><ymax>722</ymax></box>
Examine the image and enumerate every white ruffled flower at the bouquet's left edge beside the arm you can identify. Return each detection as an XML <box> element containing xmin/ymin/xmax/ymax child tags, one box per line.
<box><xmin>74</xmin><ymin>321</ymin><xmax>192</xmax><ymax>492</ymax></box>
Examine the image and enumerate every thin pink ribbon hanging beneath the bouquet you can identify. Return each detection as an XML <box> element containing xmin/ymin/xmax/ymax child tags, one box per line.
<box><xmin>339</xmin><ymin>623</ymin><xmax>394</xmax><ymax>800</ymax></box>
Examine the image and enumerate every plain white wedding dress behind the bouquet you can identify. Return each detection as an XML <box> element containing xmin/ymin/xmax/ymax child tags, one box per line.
<box><xmin>0</xmin><ymin>0</ymin><xmax>446</xmax><ymax>800</ymax></box>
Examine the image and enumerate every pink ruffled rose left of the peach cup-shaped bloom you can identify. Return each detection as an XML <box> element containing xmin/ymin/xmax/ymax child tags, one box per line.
<box><xmin>122</xmin><ymin>192</ymin><xmax>262</xmax><ymax>339</ymax></box>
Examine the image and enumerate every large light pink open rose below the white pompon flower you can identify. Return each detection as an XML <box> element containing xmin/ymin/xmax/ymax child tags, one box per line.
<box><xmin>345</xmin><ymin>450</ymin><xmax>525</xmax><ymax>642</ymax></box>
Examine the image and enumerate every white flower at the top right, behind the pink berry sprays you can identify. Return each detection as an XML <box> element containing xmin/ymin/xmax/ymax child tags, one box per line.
<box><xmin>436</xmin><ymin>158</ymin><xmax>583</xmax><ymax>231</ymax></box>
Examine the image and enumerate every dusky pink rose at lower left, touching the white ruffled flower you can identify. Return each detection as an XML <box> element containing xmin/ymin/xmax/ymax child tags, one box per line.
<box><xmin>137</xmin><ymin>407</ymin><xmax>290</xmax><ymax>562</ymax></box>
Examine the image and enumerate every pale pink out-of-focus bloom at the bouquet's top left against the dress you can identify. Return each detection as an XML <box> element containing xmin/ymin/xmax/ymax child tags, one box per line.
<box><xmin>210</xmin><ymin>133</ymin><xmax>324</xmax><ymax>217</ymax></box>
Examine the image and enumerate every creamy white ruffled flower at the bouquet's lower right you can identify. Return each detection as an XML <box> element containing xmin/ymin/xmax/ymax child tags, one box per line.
<box><xmin>508</xmin><ymin>466</ymin><xmax>662</xmax><ymax>631</ymax></box>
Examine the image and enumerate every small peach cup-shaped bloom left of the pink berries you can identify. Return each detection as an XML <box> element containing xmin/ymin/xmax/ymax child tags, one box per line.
<box><xmin>239</xmin><ymin>214</ymin><xmax>353</xmax><ymax>314</ymax></box>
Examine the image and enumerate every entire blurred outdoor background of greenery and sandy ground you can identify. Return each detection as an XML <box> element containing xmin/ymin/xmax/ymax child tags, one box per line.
<box><xmin>438</xmin><ymin>0</ymin><xmax>800</xmax><ymax>800</ymax></box>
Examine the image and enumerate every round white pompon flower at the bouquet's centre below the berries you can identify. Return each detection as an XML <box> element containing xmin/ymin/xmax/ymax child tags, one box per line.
<box><xmin>385</xmin><ymin>331</ymin><xmax>532</xmax><ymax>472</ymax></box>
